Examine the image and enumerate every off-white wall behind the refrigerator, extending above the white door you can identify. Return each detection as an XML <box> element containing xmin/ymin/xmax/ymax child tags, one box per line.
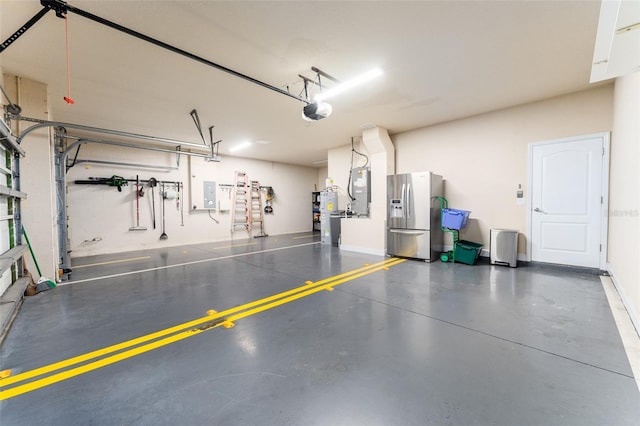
<box><xmin>391</xmin><ymin>85</ymin><xmax>615</xmax><ymax>254</ymax></box>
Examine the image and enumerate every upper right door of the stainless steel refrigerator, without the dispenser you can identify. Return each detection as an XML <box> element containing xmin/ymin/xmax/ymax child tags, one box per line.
<box><xmin>408</xmin><ymin>172</ymin><xmax>431</xmax><ymax>230</ymax></box>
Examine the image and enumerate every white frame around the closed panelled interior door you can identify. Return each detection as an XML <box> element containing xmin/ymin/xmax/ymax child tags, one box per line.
<box><xmin>526</xmin><ymin>132</ymin><xmax>610</xmax><ymax>270</ymax></box>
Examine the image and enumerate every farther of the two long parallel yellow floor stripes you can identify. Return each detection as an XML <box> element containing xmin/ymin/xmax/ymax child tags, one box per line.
<box><xmin>0</xmin><ymin>258</ymin><xmax>395</xmax><ymax>388</ymax></box>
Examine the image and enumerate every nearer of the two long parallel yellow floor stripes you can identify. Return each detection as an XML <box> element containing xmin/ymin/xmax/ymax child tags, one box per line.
<box><xmin>0</xmin><ymin>258</ymin><xmax>406</xmax><ymax>400</ymax></box>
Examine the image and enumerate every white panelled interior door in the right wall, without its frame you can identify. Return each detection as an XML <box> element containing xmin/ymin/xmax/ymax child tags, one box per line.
<box><xmin>530</xmin><ymin>135</ymin><xmax>605</xmax><ymax>268</ymax></box>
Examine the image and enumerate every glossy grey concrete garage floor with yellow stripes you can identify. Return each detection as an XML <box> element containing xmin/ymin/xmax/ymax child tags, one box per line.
<box><xmin>0</xmin><ymin>234</ymin><xmax>640</xmax><ymax>425</ymax></box>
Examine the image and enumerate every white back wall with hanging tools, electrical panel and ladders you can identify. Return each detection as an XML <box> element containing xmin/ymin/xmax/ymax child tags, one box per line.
<box><xmin>67</xmin><ymin>144</ymin><xmax>318</xmax><ymax>258</ymax></box>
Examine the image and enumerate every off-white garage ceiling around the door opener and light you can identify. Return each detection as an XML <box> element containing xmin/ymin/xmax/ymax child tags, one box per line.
<box><xmin>0</xmin><ymin>0</ymin><xmax>600</xmax><ymax>166</ymax></box>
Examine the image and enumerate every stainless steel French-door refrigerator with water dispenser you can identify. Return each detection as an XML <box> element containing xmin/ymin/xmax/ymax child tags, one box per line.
<box><xmin>387</xmin><ymin>172</ymin><xmax>443</xmax><ymax>261</ymax></box>
